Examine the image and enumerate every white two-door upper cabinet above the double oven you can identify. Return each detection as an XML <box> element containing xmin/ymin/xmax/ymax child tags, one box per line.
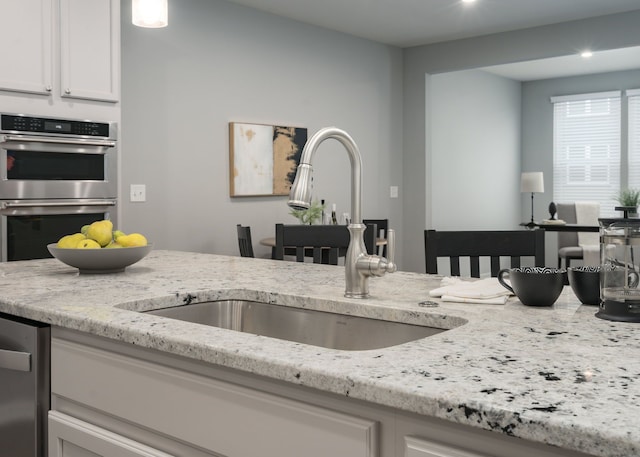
<box><xmin>0</xmin><ymin>0</ymin><xmax>120</xmax><ymax>102</ymax></box>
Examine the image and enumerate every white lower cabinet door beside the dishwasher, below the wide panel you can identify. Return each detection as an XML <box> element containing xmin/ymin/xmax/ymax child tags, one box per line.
<box><xmin>49</xmin><ymin>411</ymin><xmax>174</xmax><ymax>457</ymax></box>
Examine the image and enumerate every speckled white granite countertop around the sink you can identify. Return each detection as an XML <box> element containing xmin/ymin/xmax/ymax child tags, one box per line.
<box><xmin>0</xmin><ymin>251</ymin><xmax>640</xmax><ymax>457</ymax></box>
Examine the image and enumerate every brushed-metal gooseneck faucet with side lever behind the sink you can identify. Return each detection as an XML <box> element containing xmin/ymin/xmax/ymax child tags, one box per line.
<box><xmin>289</xmin><ymin>127</ymin><xmax>397</xmax><ymax>298</ymax></box>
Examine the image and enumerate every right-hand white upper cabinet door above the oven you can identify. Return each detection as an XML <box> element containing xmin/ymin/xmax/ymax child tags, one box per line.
<box><xmin>60</xmin><ymin>0</ymin><xmax>120</xmax><ymax>102</ymax></box>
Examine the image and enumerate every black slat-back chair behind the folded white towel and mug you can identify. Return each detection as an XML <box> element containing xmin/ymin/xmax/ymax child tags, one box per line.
<box><xmin>424</xmin><ymin>230</ymin><xmax>544</xmax><ymax>278</ymax></box>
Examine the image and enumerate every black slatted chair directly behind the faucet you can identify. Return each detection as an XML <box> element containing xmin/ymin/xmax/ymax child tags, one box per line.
<box><xmin>273</xmin><ymin>224</ymin><xmax>377</xmax><ymax>265</ymax></box>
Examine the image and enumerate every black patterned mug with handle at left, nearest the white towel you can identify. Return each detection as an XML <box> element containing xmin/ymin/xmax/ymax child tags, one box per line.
<box><xmin>498</xmin><ymin>267</ymin><xmax>566</xmax><ymax>306</ymax></box>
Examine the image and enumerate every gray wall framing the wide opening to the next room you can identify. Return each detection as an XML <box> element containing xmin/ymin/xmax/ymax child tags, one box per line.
<box><xmin>400</xmin><ymin>10</ymin><xmax>640</xmax><ymax>271</ymax></box>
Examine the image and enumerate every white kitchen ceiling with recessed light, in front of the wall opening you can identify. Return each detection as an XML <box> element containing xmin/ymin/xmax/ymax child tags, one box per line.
<box><xmin>224</xmin><ymin>0</ymin><xmax>640</xmax><ymax>47</ymax></box>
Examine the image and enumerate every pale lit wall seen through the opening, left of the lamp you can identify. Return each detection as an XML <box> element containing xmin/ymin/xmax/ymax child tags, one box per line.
<box><xmin>428</xmin><ymin>70</ymin><xmax>521</xmax><ymax>230</ymax></box>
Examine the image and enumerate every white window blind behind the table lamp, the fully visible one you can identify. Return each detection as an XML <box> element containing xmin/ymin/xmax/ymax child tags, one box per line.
<box><xmin>551</xmin><ymin>91</ymin><xmax>620</xmax><ymax>217</ymax></box>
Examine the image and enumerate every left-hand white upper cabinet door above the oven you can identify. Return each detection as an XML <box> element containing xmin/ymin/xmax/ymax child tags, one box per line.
<box><xmin>0</xmin><ymin>0</ymin><xmax>53</xmax><ymax>94</ymax></box>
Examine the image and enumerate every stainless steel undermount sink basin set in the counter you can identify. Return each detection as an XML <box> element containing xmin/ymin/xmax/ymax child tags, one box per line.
<box><xmin>145</xmin><ymin>300</ymin><xmax>444</xmax><ymax>351</ymax></box>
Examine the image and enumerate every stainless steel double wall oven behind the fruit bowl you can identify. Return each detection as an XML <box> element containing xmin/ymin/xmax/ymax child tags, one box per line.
<box><xmin>0</xmin><ymin>113</ymin><xmax>118</xmax><ymax>262</ymax></box>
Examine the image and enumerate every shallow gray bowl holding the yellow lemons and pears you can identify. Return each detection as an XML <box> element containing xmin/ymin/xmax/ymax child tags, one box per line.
<box><xmin>47</xmin><ymin>243</ymin><xmax>153</xmax><ymax>273</ymax></box>
